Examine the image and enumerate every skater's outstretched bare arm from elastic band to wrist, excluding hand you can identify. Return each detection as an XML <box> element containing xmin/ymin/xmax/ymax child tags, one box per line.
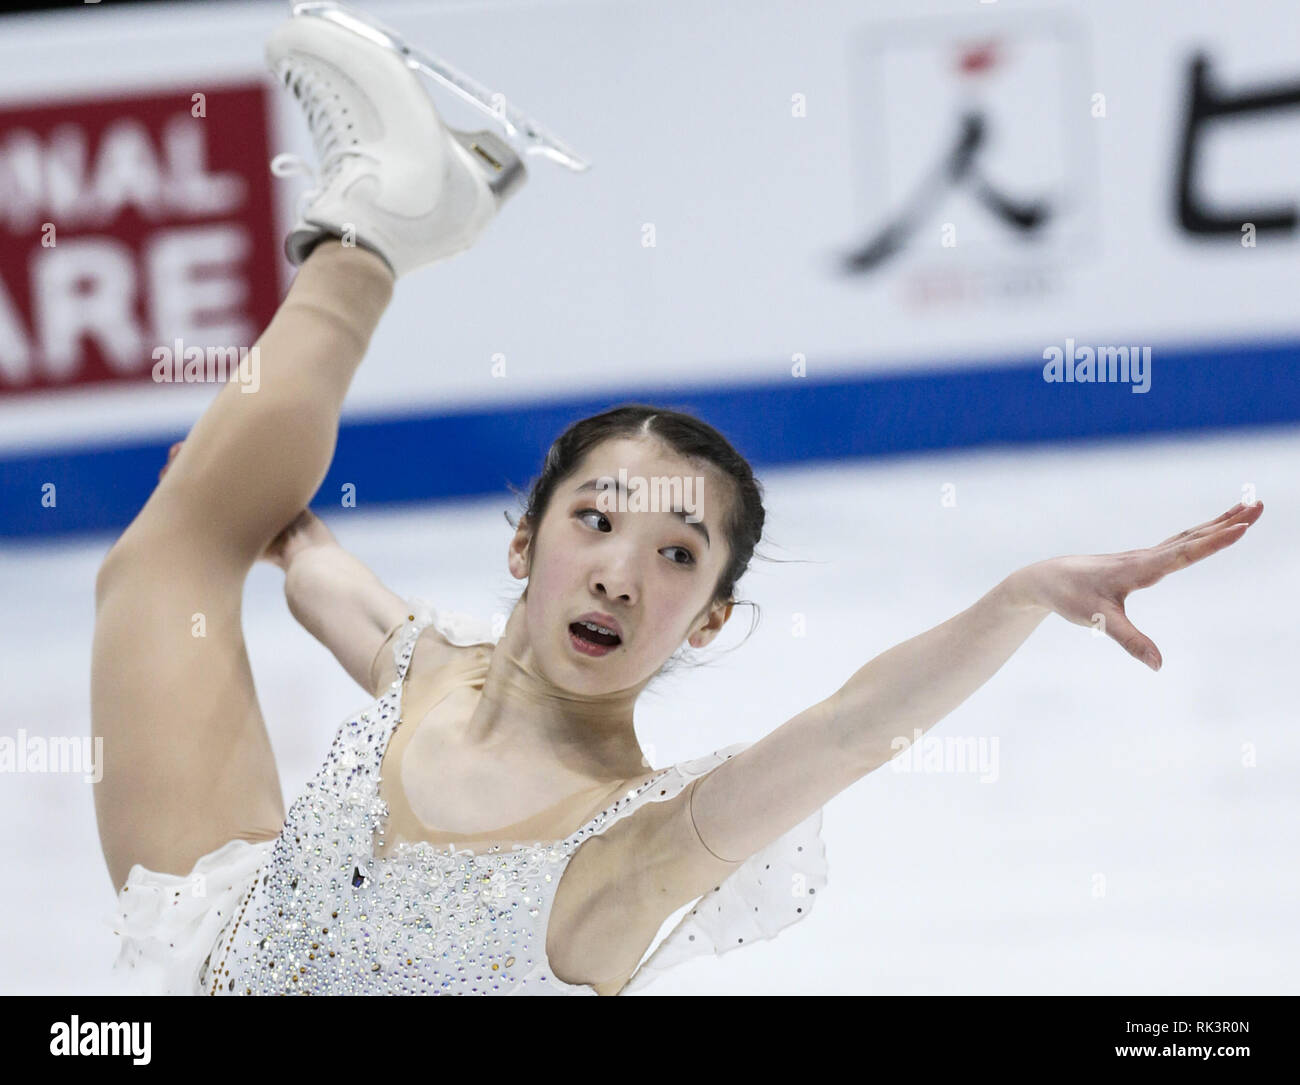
<box><xmin>690</xmin><ymin>573</ymin><xmax>1052</xmax><ymax>862</ymax></box>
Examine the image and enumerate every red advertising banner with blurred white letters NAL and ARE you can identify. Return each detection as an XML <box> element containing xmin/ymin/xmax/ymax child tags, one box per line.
<box><xmin>0</xmin><ymin>82</ymin><xmax>282</xmax><ymax>395</ymax></box>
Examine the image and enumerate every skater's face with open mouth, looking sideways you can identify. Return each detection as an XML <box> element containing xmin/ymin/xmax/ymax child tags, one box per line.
<box><xmin>510</xmin><ymin>438</ymin><xmax>733</xmax><ymax>694</ymax></box>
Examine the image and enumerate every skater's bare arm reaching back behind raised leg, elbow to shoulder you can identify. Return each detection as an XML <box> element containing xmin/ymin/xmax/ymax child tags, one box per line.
<box><xmin>285</xmin><ymin>543</ymin><xmax>408</xmax><ymax>695</ymax></box>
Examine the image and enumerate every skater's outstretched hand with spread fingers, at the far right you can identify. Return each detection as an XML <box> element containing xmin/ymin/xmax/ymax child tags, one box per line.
<box><xmin>1011</xmin><ymin>502</ymin><xmax>1264</xmax><ymax>670</ymax></box>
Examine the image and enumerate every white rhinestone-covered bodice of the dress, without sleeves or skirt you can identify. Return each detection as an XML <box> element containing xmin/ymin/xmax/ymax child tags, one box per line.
<box><xmin>199</xmin><ymin>617</ymin><xmax>680</xmax><ymax>994</ymax></box>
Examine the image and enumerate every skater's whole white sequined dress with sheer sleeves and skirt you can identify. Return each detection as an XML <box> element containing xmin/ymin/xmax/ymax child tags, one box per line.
<box><xmin>112</xmin><ymin>600</ymin><xmax>827</xmax><ymax>994</ymax></box>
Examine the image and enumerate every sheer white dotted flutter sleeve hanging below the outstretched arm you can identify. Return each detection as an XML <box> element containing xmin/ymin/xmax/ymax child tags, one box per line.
<box><xmin>620</xmin><ymin>742</ymin><xmax>827</xmax><ymax>994</ymax></box>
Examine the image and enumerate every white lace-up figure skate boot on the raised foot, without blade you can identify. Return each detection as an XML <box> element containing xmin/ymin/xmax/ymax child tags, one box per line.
<box><xmin>267</xmin><ymin>4</ymin><xmax>546</xmax><ymax>277</ymax></box>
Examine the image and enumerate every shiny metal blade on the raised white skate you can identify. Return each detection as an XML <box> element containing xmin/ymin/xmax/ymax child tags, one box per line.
<box><xmin>294</xmin><ymin>0</ymin><xmax>592</xmax><ymax>173</ymax></box>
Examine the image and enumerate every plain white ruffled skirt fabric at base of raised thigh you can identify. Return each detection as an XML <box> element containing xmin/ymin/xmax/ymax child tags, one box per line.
<box><xmin>111</xmin><ymin>839</ymin><xmax>276</xmax><ymax>994</ymax></box>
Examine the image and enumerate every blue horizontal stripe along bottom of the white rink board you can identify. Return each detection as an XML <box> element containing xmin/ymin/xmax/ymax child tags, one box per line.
<box><xmin>0</xmin><ymin>340</ymin><xmax>1300</xmax><ymax>539</ymax></box>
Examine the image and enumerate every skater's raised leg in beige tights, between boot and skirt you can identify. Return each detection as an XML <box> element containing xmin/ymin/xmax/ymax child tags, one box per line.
<box><xmin>91</xmin><ymin>242</ymin><xmax>393</xmax><ymax>889</ymax></box>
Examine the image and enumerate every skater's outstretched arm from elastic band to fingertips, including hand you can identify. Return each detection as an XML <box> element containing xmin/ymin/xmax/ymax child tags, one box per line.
<box><xmin>689</xmin><ymin>503</ymin><xmax>1264</xmax><ymax>862</ymax></box>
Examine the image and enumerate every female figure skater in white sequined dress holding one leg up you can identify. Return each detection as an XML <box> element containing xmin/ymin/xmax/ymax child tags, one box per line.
<box><xmin>91</xmin><ymin>4</ymin><xmax>1262</xmax><ymax>994</ymax></box>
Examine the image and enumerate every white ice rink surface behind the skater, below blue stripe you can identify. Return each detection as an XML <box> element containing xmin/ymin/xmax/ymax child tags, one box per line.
<box><xmin>0</xmin><ymin>421</ymin><xmax>1300</xmax><ymax>995</ymax></box>
